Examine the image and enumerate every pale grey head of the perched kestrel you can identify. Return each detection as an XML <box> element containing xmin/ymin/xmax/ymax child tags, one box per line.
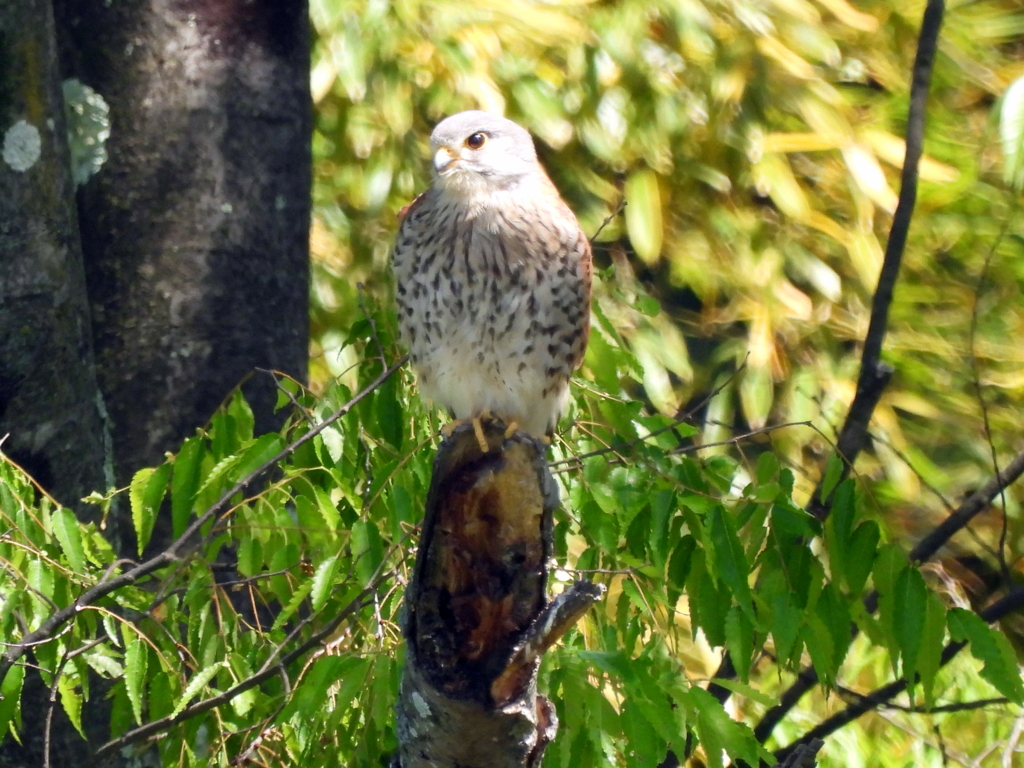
<box><xmin>430</xmin><ymin>111</ymin><xmax>544</xmax><ymax>197</ymax></box>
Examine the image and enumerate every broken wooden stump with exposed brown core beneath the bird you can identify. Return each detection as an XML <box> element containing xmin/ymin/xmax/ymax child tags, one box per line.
<box><xmin>393</xmin><ymin>424</ymin><xmax>603</xmax><ymax>768</ymax></box>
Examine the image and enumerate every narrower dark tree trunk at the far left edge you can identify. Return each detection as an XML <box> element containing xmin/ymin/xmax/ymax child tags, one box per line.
<box><xmin>0</xmin><ymin>0</ymin><xmax>105</xmax><ymax>514</ymax></box>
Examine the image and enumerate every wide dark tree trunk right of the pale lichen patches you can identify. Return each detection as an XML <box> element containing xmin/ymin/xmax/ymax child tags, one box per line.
<box><xmin>55</xmin><ymin>0</ymin><xmax>311</xmax><ymax>514</ymax></box>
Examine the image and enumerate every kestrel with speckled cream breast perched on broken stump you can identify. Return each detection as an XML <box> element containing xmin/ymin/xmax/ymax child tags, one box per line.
<box><xmin>391</xmin><ymin>112</ymin><xmax>592</xmax><ymax>437</ymax></box>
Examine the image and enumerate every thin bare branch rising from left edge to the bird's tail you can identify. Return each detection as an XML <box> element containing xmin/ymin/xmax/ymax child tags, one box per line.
<box><xmin>0</xmin><ymin>355</ymin><xmax>408</xmax><ymax>680</ymax></box>
